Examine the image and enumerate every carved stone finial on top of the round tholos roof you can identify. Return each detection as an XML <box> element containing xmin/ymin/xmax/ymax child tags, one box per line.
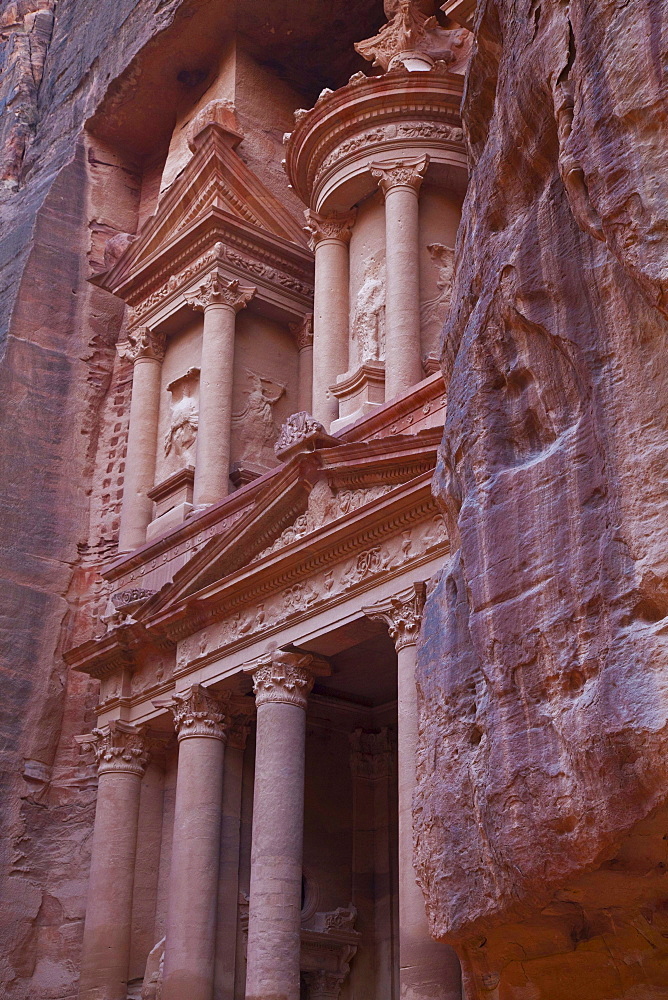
<box><xmin>355</xmin><ymin>0</ymin><xmax>472</xmax><ymax>72</ymax></box>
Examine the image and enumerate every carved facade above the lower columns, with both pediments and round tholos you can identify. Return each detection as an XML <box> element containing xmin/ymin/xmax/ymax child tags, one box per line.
<box><xmin>68</xmin><ymin>0</ymin><xmax>471</xmax><ymax>721</ymax></box>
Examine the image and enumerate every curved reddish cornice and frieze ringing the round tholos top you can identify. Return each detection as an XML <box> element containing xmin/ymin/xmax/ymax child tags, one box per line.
<box><xmin>285</xmin><ymin>63</ymin><xmax>465</xmax><ymax>206</ymax></box>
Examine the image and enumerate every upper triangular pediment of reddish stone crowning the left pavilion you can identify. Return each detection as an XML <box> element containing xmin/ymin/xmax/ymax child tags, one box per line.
<box><xmin>103</xmin><ymin>123</ymin><xmax>306</xmax><ymax>289</ymax></box>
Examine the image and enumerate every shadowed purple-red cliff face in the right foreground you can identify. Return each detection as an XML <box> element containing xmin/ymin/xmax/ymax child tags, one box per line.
<box><xmin>415</xmin><ymin>0</ymin><xmax>668</xmax><ymax>1000</ymax></box>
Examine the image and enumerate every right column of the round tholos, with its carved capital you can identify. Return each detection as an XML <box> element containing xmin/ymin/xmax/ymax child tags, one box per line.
<box><xmin>371</xmin><ymin>156</ymin><xmax>429</xmax><ymax>400</ymax></box>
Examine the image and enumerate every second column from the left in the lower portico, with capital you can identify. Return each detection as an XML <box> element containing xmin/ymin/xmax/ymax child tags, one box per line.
<box><xmin>162</xmin><ymin>684</ymin><xmax>232</xmax><ymax>1000</ymax></box>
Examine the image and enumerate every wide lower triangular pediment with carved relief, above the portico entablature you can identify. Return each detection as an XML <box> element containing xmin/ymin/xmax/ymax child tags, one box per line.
<box><xmin>138</xmin><ymin>427</ymin><xmax>442</xmax><ymax>621</ymax></box>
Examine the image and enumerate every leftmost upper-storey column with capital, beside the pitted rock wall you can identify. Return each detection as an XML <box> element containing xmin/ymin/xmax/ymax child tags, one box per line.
<box><xmin>118</xmin><ymin>326</ymin><xmax>165</xmax><ymax>552</ymax></box>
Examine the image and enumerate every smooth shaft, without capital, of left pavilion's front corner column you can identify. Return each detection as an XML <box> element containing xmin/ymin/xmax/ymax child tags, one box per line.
<box><xmin>193</xmin><ymin>302</ymin><xmax>237</xmax><ymax>504</ymax></box>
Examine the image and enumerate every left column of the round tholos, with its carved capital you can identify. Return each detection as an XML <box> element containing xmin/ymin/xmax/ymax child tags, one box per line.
<box><xmin>304</xmin><ymin>211</ymin><xmax>355</xmax><ymax>430</ymax></box>
